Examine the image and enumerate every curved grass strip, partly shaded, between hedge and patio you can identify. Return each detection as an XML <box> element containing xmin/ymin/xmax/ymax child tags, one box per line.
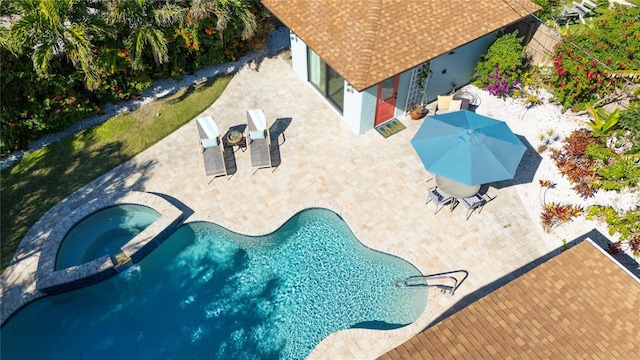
<box><xmin>0</xmin><ymin>75</ymin><xmax>232</xmax><ymax>270</ymax></box>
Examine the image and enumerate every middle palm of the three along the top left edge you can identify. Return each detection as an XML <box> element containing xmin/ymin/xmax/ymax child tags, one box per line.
<box><xmin>106</xmin><ymin>0</ymin><xmax>185</xmax><ymax>70</ymax></box>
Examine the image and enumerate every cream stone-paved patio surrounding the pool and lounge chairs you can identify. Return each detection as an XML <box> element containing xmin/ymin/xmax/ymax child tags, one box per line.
<box><xmin>0</xmin><ymin>53</ymin><xmax>559</xmax><ymax>359</ymax></box>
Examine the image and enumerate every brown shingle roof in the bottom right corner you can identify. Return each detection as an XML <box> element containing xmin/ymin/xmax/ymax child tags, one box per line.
<box><xmin>380</xmin><ymin>241</ymin><xmax>640</xmax><ymax>359</ymax></box>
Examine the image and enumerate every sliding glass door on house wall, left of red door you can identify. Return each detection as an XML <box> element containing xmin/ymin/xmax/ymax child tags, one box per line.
<box><xmin>307</xmin><ymin>48</ymin><xmax>344</xmax><ymax>112</ymax></box>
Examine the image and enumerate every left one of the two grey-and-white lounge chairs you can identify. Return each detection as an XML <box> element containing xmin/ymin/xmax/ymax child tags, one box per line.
<box><xmin>196</xmin><ymin>116</ymin><xmax>229</xmax><ymax>177</ymax></box>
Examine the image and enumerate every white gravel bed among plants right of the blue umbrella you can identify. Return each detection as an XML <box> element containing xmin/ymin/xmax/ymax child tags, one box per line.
<box><xmin>462</xmin><ymin>85</ymin><xmax>640</xmax><ymax>270</ymax></box>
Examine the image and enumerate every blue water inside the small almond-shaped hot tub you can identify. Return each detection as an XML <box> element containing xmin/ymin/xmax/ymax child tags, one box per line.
<box><xmin>55</xmin><ymin>204</ymin><xmax>160</xmax><ymax>270</ymax></box>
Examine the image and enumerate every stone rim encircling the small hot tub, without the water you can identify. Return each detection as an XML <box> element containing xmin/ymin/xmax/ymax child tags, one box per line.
<box><xmin>36</xmin><ymin>191</ymin><xmax>184</xmax><ymax>294</ymax></box>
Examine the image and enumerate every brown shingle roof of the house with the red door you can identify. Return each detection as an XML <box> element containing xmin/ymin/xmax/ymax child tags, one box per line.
<box><xmin>262</xmin><ymin>0</ymin><xmax>540</xmax><ymax>91</ymax></box>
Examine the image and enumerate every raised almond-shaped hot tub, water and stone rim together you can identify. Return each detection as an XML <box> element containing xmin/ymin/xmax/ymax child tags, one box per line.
<box><xmin>36</xmin><ymin>191</ymin><xmax>183</xmax><ymax>294</ymax></box>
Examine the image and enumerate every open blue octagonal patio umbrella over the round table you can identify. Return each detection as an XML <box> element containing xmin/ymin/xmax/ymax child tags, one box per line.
<box><xmin>411</xmin><ymin>110</ymin><xmax>526</xmax><ymax>185</ymax></box>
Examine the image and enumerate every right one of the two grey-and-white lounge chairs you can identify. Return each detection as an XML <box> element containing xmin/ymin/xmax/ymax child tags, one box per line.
<box><xmin>247</xmin><ymin>109</ymin><xmax>272</xmax><ymax>174</ymax></box>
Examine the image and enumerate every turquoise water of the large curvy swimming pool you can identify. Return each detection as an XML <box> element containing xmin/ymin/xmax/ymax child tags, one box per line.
<box><xmin>5</xmin><ymin>209</ymin><xmax>427</xmax><ymax>360</ymax></box>
